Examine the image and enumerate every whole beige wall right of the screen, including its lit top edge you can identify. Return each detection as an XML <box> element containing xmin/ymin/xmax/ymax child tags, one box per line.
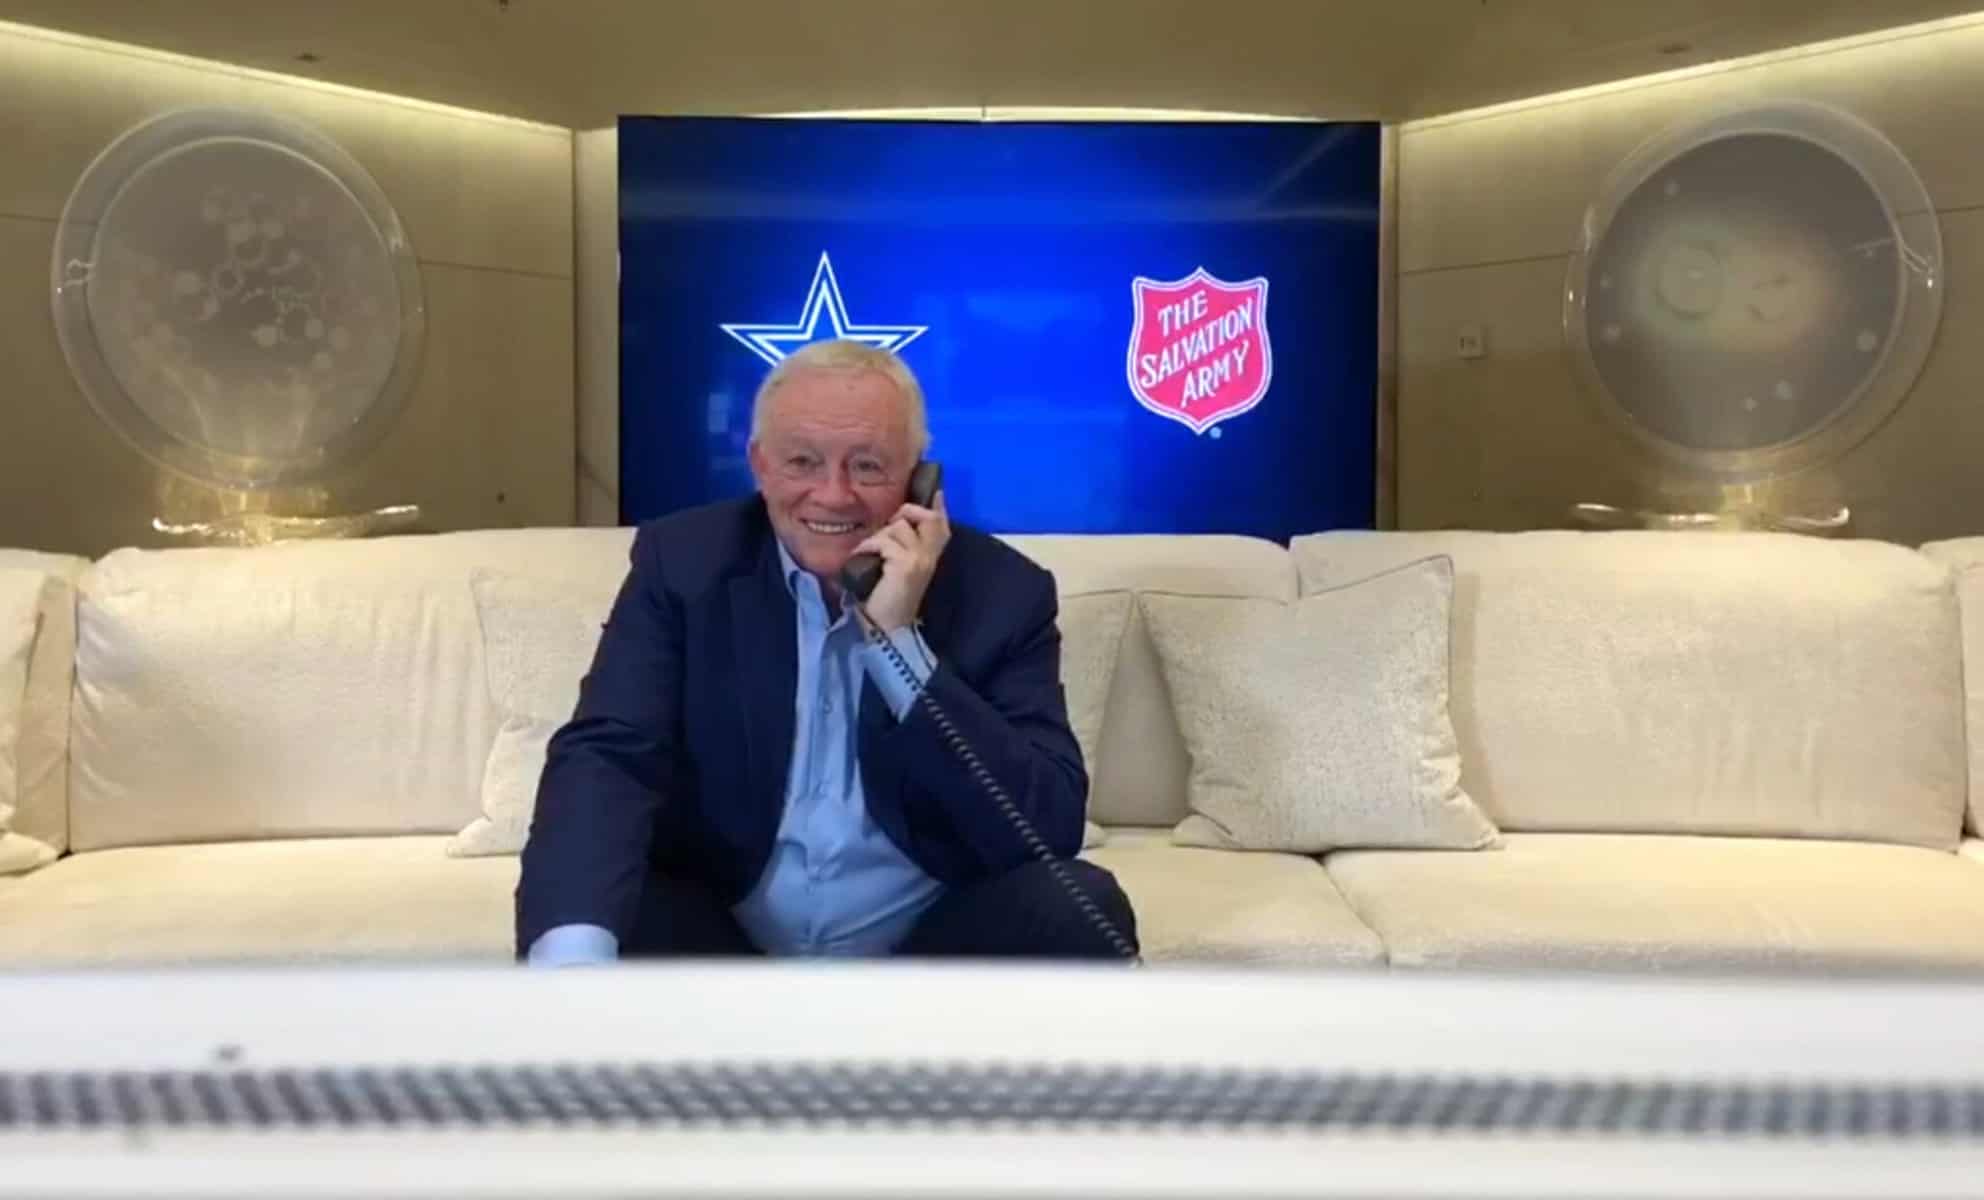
<box><xmin>1399</xmin><ymin>20</ymin><xmax>1984</xmax><ymax>543</ymax></box>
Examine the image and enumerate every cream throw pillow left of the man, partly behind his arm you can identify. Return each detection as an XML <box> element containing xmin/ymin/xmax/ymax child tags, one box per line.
<box><xmin>448</xmin><ymin>569</ymin><xmax>615</xmax><ymax>859</ymax></box>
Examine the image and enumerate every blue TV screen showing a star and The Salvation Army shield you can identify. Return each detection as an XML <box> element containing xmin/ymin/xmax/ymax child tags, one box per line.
<box><xmin>619</xmin><ymin>117</ymin><xmax>1379</xmax><ymax>540</ymax></box>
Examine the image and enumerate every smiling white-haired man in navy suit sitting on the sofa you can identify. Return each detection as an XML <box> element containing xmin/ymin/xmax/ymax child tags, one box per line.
<box><xmin>516</xmin><ymin>341</ymin><xmax>1137</xmax><ymax>966</ymax></box>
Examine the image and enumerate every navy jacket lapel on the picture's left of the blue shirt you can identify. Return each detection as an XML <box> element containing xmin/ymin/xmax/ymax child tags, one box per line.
<box><xmin>730</xmin><ymin>530</ymin><xmax>800</xmax><ymax>827</ymax></box>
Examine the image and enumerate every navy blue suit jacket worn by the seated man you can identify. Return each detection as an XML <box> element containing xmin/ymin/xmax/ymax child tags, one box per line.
<box><xmin>516</xmin><ymin>496</ymin><xmax>1089</xmax><ymax>954</ymax></box>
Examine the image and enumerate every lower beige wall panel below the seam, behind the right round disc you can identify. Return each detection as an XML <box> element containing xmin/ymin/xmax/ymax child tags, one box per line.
<box><xmin>1399</xmin><ymin>210</ymin><xmax>1984</xmax><ymax>543</ymax></box>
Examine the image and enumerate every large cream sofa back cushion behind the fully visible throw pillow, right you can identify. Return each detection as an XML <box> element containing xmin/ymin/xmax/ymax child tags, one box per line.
<box><xmin>1292</xmin><ymin>532</ymin><xmax>1966</xmax><ymax>851</ymax></box>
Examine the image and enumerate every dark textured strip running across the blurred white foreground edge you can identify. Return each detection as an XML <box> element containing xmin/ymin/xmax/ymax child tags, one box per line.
<box><xmin>0</xmin><ymin>1063</ymin><xmax>1984</xmax><ymax>1140</ymax></box>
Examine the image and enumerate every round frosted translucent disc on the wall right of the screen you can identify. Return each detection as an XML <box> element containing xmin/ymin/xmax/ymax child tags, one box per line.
<box><xmin>1563</xmin><ymin>103</ymin><xmax>1942</xmax><ymax>484</ymax></box>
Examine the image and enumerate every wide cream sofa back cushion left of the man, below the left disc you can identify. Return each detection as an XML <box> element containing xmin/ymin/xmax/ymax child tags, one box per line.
<box><xmin>69</xmin><ymin>530</ymin><xmax>631</xmax><ymax>849</ymax></box>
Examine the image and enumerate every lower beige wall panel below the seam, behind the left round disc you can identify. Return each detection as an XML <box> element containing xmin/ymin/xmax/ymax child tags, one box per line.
<box><xmin>0</xmin><ymin>218</ymin><xmax>573</xmax><ymax>555</ymax></box>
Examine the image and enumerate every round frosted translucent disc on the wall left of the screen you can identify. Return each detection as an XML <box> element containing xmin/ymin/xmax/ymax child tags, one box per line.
<box><xmin>54</xmin><ymin>109</ymin><xmax>425</xmax><ymax>490</ymax></box>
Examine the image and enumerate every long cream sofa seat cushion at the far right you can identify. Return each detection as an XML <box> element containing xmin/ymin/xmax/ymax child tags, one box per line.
<box><xmin>1325</xmin><ymin>833</ymin><xmax>1984</xmax><ymax>972</ymax></box>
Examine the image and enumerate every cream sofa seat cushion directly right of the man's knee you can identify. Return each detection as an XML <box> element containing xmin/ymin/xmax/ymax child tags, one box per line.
<box><xmin>1083</xmin><ymin>829</ymin><xmax>1385</xmax><ymax>966</ymax></box>
